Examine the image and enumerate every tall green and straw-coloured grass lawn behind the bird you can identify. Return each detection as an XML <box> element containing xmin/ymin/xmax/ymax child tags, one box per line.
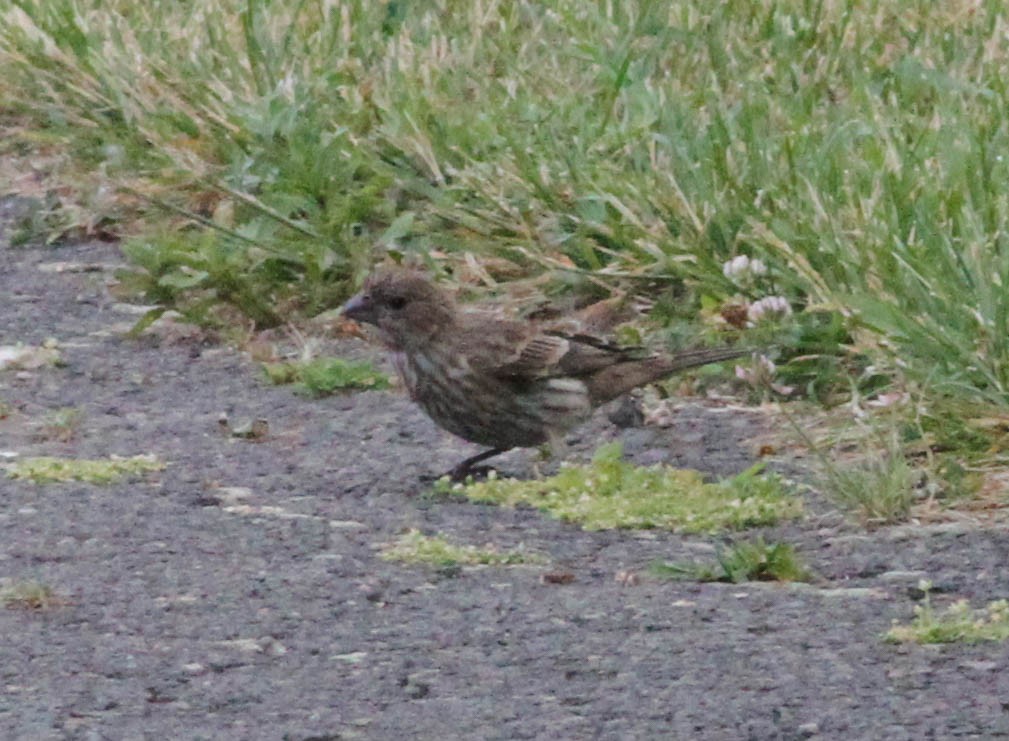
<box><xmin>0</xmin><ymin>0</ymin><xmax>1009</xmax><ymax>407</ymax></box>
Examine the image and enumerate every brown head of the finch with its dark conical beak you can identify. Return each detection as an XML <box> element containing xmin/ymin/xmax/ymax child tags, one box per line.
<box><xmin>343</xmin><ymin>268</ymin><xmax>455</xmax><ymax>350</ymax></box>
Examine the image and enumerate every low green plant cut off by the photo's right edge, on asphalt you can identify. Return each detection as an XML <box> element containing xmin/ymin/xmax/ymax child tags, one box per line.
<box><xmin>885</xmin><ymin>581</ymin><xmax>1009</xmax><ymax>643</ymax></box>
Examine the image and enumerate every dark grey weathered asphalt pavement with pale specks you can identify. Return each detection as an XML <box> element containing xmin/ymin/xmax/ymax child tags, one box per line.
<box><xmin>0</xmin><ymin>222</ymin><xmax>1009</xmax><ymax>741</ymax></box>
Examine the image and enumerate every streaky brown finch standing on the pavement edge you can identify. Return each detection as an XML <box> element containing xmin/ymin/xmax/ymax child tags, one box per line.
<box><xmin>343</xmin><ymin>268</ymin><xmax>749</xmax><ymax>480</ymax></box>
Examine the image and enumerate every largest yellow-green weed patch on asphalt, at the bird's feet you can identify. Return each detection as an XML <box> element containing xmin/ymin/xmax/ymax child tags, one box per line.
<box><xmin>437</xmin><ymin>443</ymin><xmax>802</xmax><ymax>533</ymax></box>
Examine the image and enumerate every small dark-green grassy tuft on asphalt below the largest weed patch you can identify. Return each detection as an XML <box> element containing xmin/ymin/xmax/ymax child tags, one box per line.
<box><xmin>652</xmin><ymin>538</ymin><xmax>810</xmax><ymax>584</ymax></box>
